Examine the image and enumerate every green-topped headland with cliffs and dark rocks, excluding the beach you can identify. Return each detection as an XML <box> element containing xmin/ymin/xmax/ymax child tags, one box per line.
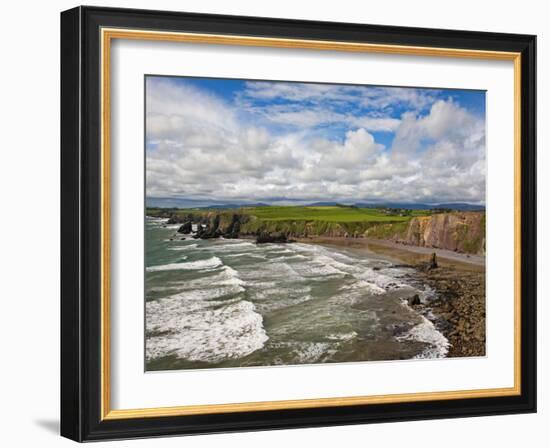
<box><xmin>147</xmin><ymin>205</ymin><xmax>485</xmax><ymax>256</ymax></box>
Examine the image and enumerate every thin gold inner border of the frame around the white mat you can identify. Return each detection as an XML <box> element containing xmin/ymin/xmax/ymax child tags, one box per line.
<box><xmin>100</xmin><ymin>28</ymin><xmax>521</xmax><ymax>420</ymax></box>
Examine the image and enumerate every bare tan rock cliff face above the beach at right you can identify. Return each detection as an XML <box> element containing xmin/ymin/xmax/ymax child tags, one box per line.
<box><xmin>366</xmin><ymin>212</ymin><xmax>485</xmax><ymax>255</ymax></box>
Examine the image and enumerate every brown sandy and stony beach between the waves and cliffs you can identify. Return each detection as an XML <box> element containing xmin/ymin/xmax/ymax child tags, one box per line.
<box><xmin>297</xmin><ymin>237</ymin><xmax>486</xmax><ymax>358</ymax></box>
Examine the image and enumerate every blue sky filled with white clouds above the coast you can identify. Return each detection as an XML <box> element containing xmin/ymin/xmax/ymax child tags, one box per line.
<box><xmin>146</xmin><ymin>76</ymin><xmax>485</xmax><ymax>203</ymax></box>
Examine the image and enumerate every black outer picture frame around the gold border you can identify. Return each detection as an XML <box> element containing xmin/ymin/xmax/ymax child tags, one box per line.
<box><xmin>61</xmin><ymin>7</ymin><xmax>537</xmax><ymax>441</ymax></box>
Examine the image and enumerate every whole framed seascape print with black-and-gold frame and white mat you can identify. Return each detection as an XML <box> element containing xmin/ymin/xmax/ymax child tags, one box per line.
<box><xmin>61</xmin><ymin>7</ymin><xmax>536</xmax><ymax>441</ymax></box>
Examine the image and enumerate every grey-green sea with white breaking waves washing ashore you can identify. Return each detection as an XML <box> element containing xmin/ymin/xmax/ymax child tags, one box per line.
<box><xmin>145</xmin><ymin>217</ymin><xmax>448</xmax><ymax>370</ymax></box>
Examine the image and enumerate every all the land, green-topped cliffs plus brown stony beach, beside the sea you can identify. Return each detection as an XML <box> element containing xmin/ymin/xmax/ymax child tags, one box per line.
<box><xmin>146</xmin><ymin>206</ymin><xmax>486</xmax><ymax>357</ymax></box>
